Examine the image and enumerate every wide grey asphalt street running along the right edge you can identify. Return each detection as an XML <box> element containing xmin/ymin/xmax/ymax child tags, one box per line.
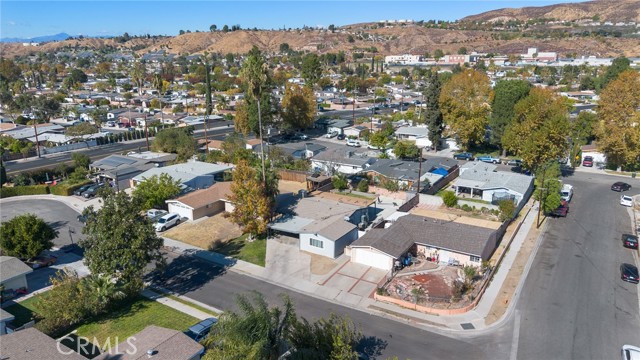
<box><xmin>514</xmin><ymin>172</ymin><xmax>640</xmax><ymax>360</ymax></box>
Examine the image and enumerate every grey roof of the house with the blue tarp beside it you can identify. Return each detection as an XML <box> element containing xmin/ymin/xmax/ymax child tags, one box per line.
<box><xmin>367</xmin><ymin>157</ymin><xmax>458</xmax><ymax>181</ymax></box>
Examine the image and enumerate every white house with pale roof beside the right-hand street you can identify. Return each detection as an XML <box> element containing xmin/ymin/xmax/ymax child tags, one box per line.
<box><xmin>453</xmin><ymin>162</ymin><xmax>533</xmax><ymax>211</ymax></box>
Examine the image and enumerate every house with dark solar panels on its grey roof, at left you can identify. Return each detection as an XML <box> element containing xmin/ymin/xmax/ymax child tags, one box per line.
<box><xmin>90</xmin><ymin>151</ymin><xmax>177</xmax><ymax>190</ymax></box>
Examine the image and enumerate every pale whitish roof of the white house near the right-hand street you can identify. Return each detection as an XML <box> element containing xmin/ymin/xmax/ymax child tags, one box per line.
<box><xmin>455</xmin><ymin>169</ymin><xmax>533</xmax><ymax>195</ymax></box>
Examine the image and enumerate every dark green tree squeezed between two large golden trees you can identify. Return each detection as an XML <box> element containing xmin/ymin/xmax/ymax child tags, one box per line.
<box><xmin>489</xmin><ymin>80</ymin><xmax>531</xmax><ymax>150</ymax></box>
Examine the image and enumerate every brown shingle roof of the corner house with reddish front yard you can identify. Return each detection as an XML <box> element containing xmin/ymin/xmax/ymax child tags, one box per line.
<box><xmin>351</xmin><ymin>214</ymin><xmax>495</xmax><ymax>259</ymax></box>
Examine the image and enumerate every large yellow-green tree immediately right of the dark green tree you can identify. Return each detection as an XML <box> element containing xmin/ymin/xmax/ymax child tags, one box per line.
<box><xmin>502</xmin><ymin>88</ymin><xmax>569</xmax><ymax>171</ymax></box>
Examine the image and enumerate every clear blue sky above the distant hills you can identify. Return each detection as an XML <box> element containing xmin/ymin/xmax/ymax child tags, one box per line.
<box><xmin>0</xmin><ymin>0</ymin><xmax>578</xmax><ymax>38</ymax></box>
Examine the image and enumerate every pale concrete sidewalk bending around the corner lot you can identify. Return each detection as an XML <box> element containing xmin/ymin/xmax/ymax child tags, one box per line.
<box><xmin>164</xmin><ymin>200</ymin><xmax>540</xmax><ymax>331</ymax></box>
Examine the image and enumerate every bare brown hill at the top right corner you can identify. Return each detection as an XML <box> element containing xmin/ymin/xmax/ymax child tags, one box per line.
<box><xmin>461</xmin><ymin>0</ymin><xmax>640</xmax><ymax>22</ymax></box>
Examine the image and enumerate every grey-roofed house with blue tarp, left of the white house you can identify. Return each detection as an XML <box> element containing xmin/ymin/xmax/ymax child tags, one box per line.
<box><xmin>365</xmin><ymin>157</ymin><xmax>458</xmax><ymax>190</ymax></box>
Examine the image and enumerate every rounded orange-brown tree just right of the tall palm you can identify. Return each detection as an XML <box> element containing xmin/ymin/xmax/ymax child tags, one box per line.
<box><xmin>281</xmin><ymin>83</ymin><xmax>316</xmax><ymax>129</ymax></box>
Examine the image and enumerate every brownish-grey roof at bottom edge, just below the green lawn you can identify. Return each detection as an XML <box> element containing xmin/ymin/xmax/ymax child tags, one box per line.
<box><xmin>95</xmin><ymin>325</ymin><xmax>204</xmax><ymax>360</ymax></box>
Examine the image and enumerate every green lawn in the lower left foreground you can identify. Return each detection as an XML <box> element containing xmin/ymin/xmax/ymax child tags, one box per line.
<box><xmin>77</xmin><ymin>297</ymin><xmax>198</xmax><ymax>346</ymax></box>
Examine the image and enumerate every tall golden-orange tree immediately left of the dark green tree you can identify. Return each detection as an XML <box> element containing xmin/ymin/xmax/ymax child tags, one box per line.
<box><xmin>440</xmin><ymin>69</ymin><xmax>493</xmax><ymax>149</ymax></box>
